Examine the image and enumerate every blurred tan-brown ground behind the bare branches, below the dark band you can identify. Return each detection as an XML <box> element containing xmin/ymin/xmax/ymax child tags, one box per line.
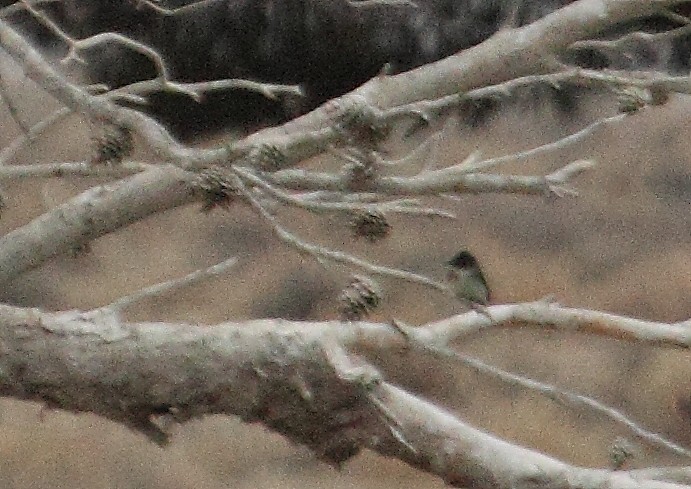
<box><xmin>0</xmin><ymin>54</ymin><xmax>691</xmax><ymax>489</ymax></box>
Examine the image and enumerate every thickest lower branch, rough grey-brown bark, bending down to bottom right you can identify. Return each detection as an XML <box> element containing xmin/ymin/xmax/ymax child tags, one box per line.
<box><xmin>0</xmin><ymin>304</ymin><xmax>689</xmax><ymax>489</ymax></box>
